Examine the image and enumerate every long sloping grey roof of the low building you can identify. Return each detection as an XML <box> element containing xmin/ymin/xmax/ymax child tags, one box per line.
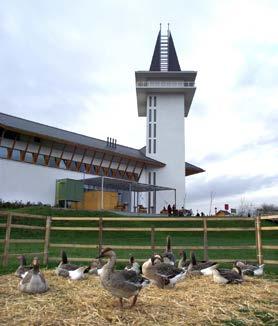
<box><xmin>0</xmin><ymin>112</ymin><xmax>165</xmax><ymax>167</ymax></box>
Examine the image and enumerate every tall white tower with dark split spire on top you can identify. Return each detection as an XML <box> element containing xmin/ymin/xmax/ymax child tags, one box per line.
<box><xmin>135</xmin><ymin>25</ymin><xmax>197</xmax><ymax>212</ymax></box>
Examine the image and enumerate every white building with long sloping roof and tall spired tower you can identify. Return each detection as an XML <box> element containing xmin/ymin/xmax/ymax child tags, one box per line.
<box><xmin>0</xmin><ymin>26</ymin><xmax>203</xmax><ymax>212</ymax></box>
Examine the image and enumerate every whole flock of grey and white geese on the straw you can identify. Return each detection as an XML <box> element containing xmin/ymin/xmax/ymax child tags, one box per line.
<box><xmin>15</xmin><ymin>236</ymin><xmax>264</xmax><ymax>307</ymax></box>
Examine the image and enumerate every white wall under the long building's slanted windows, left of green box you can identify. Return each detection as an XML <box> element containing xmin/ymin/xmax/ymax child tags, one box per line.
<box><xmin>0</xmin><ymin>159</ymin><xmax>94</xmax><ymax>205</ymax></box>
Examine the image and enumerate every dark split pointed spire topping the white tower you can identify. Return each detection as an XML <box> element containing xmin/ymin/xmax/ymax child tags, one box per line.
<box><xmin>150</xmin><ymin>30</ymin><xmax>181</xmax><ymax>71</ymax></box>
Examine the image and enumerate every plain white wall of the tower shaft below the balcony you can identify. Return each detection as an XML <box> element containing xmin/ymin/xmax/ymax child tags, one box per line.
<box><xmin>146</xmin><ymin>94</ymin><xmax>185</xmax><ymax>212</ymax></box>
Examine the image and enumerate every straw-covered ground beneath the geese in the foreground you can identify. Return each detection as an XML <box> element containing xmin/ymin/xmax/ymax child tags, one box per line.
<box><xmin>0</xmin><ymin>270</ymin><xmax>278</xmax><ymax>326</ymax></box>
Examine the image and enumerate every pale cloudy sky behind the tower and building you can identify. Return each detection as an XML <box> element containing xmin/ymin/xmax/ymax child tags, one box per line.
<box><xmin>0</xmin><ymin>0</ymin><xmax>278</xmax><ymax>214</ymax></box>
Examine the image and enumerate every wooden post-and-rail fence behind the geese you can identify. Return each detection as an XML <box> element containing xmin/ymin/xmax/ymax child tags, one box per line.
<box><xmin>0</xmin><ymin>212</ymin><xmax>278</xmax><ymax>266</ymax></box>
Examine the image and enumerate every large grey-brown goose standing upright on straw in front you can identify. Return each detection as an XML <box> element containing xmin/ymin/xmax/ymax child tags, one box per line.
<box><xmin>97</xmin><ymin>248</ymin><xmax>150</xmax><ymax>307</ymax></box>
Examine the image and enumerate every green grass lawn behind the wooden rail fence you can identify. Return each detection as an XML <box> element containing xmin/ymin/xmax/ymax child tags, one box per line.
<box><xmin>0</xmin><ymin>207</ymin><xmax>278</xmax><ymax>275</ymax></box>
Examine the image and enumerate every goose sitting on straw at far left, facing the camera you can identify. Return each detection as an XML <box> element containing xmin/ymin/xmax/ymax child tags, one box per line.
<box><xmin>19</xmin><ymin>257</ymin><xmax>49</xmax><ymax>293</ymax></box>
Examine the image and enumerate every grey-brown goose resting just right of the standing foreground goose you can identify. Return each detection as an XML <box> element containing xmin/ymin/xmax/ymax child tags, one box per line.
<box><xmin>142</xmin><ymin>255</ymin><xmax>186</xmax><ymax>289</ymax></box>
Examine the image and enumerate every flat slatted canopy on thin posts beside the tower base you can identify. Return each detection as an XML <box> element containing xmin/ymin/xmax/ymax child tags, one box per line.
<box><xmin>82</xmin><ymin>177</ymin><xmax>175</xmax><ymax>192</ymax></box>
